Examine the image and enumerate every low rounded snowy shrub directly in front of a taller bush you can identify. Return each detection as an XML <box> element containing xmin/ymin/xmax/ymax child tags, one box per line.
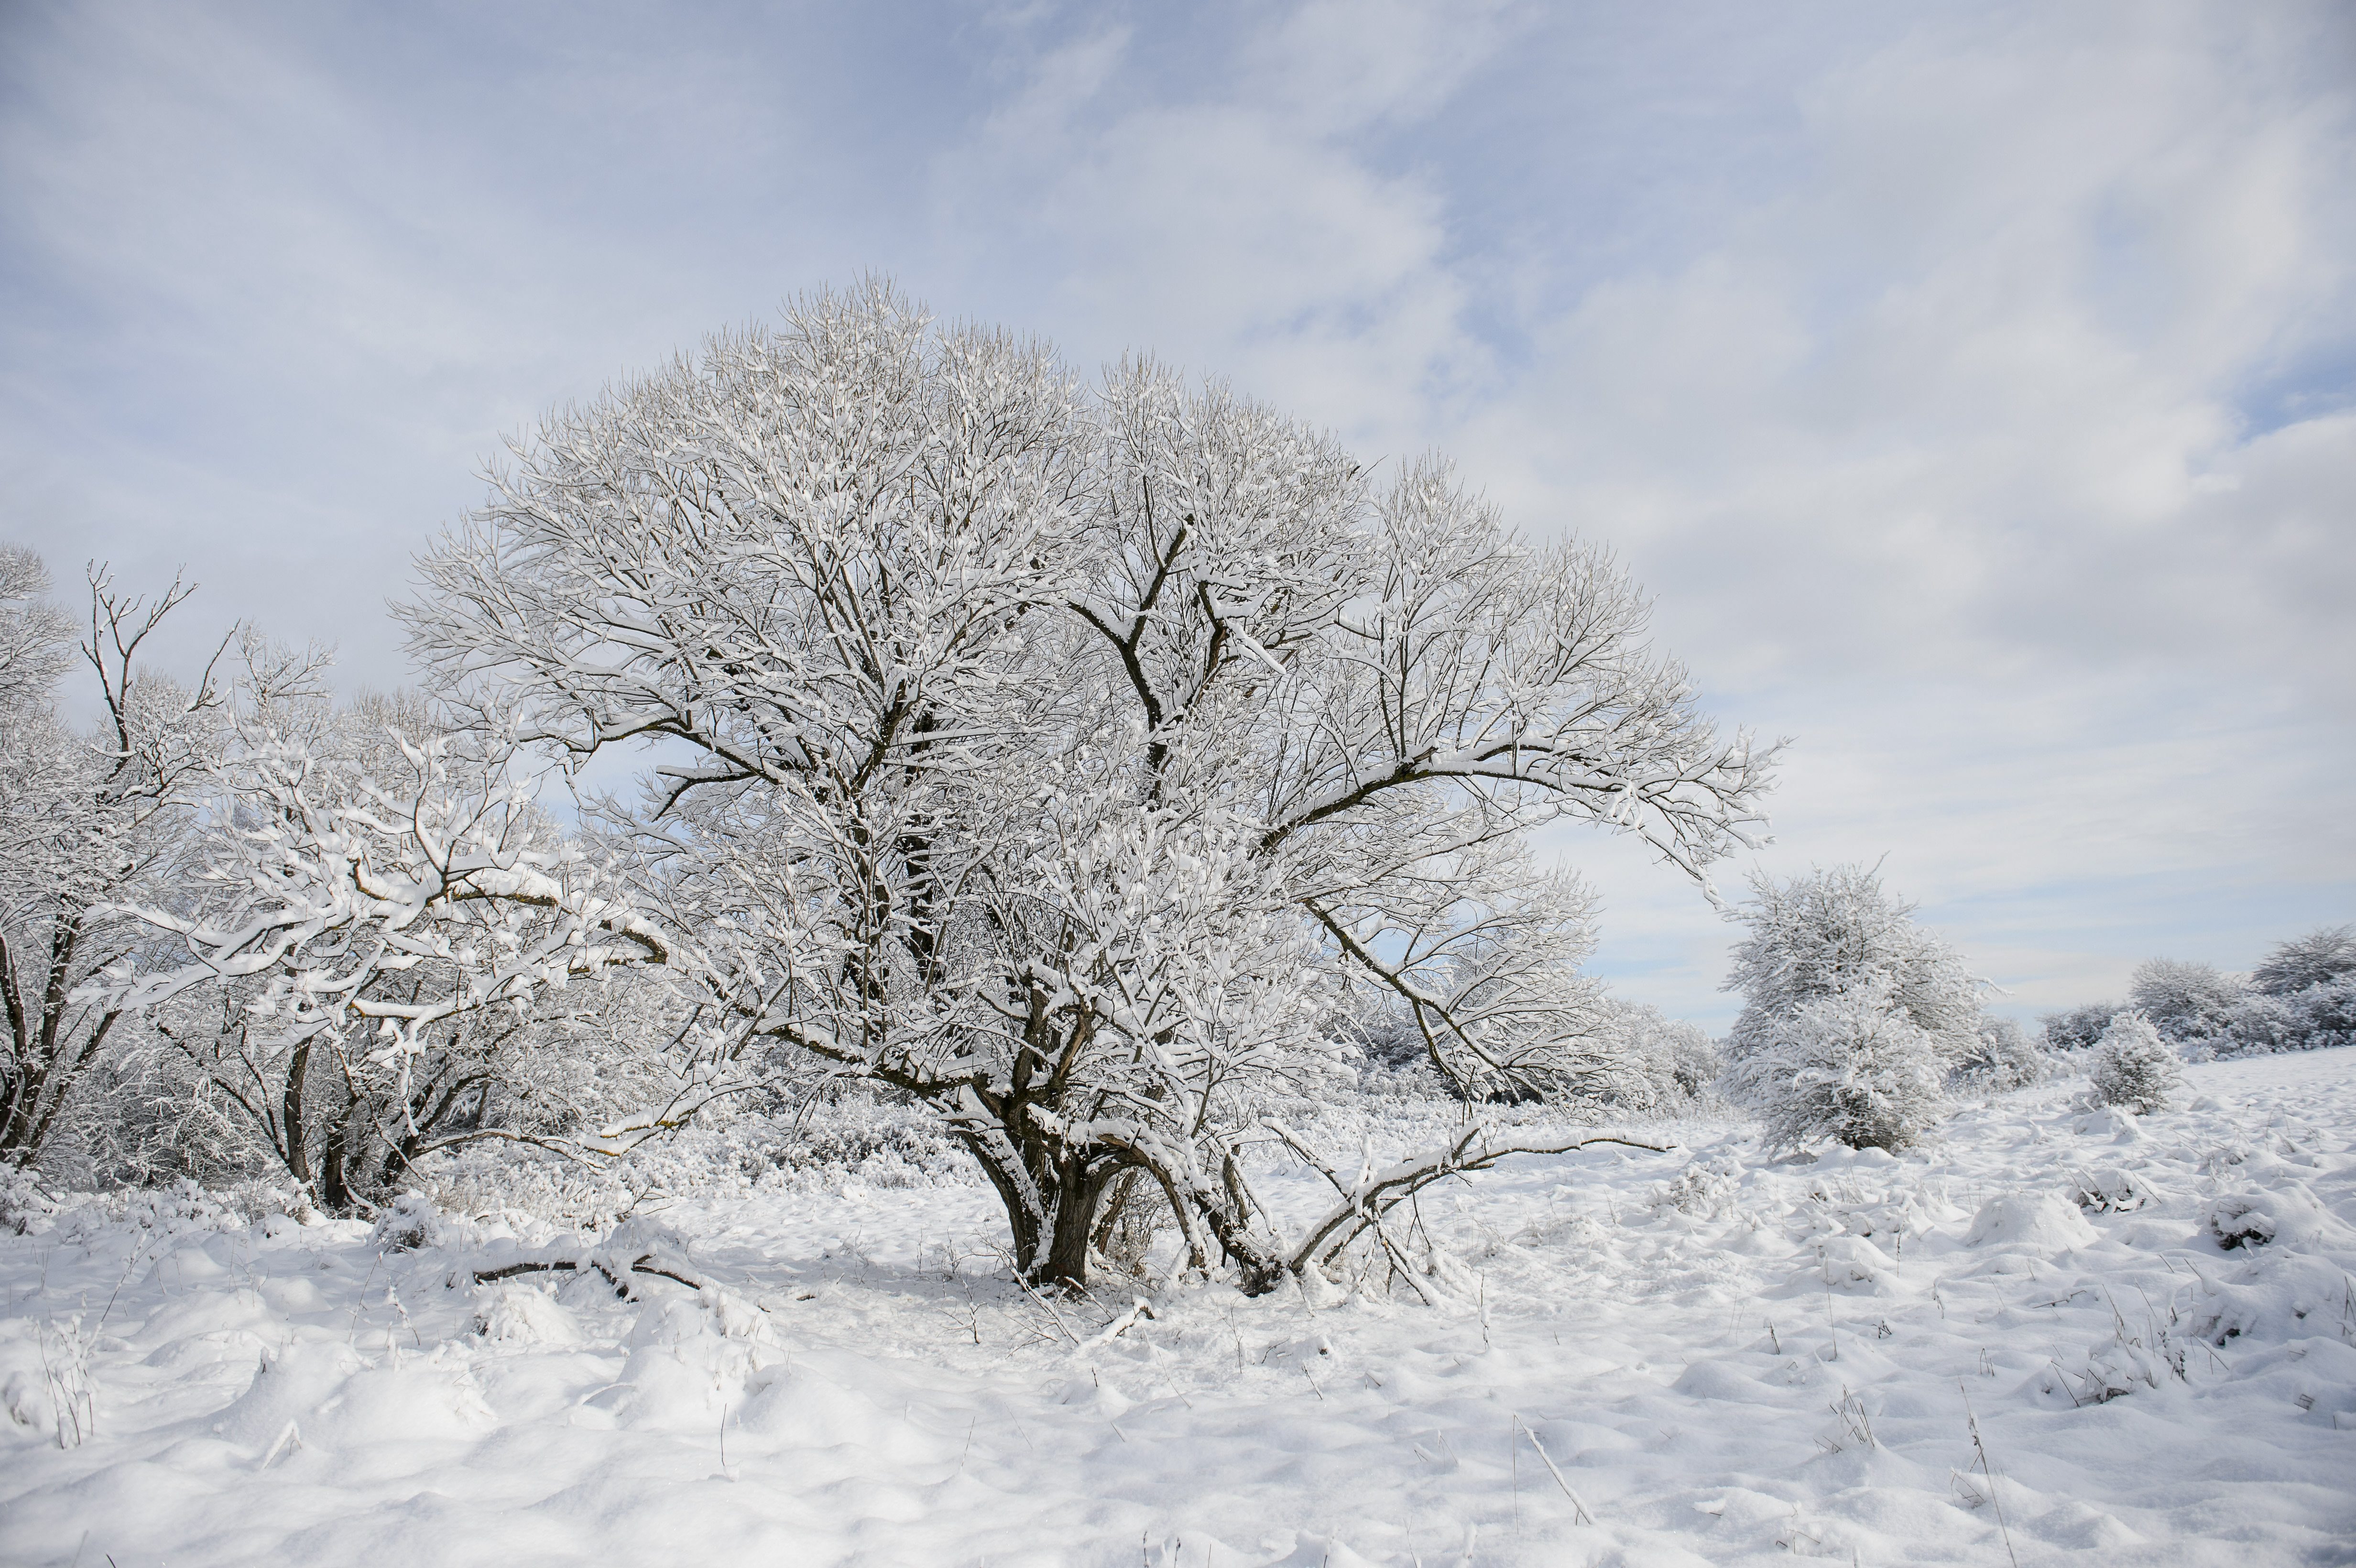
<box><xmin>1727</xmin><ymin>980</ymin><xmax>1946</xmax><ymax>1149</ymax></box>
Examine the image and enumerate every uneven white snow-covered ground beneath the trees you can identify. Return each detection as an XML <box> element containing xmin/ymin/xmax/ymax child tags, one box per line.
<box><xmin>0</xmin><ymin>1052</ymin><xmax>2356</xmax><ymax>1568</ymax></box>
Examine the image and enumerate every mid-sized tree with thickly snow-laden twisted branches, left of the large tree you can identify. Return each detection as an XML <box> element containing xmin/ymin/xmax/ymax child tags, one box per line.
<box><xmin>92</xmin><ymin>643</ymin><xmax>716</xmax><ymax>1212</ymax></box>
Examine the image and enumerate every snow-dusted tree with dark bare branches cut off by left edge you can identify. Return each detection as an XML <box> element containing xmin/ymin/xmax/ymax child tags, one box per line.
<box><xmin>0</xmin><ymin>549</ymin><xmax>217</xmax><ymax>1163</ymax></box>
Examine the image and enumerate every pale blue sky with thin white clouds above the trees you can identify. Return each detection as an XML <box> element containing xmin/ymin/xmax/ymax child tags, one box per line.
<box><xmin>0</xmin><ymin>0</ymin><xmax>2356</xmax><ymax>1024</ymax></box>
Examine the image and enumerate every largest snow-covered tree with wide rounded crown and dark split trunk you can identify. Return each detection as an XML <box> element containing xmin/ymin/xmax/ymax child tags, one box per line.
<box><xmin>403</xmin><ymin>285</ymin><xmax>1762</xmax><ymax>1288</ymax></box>
